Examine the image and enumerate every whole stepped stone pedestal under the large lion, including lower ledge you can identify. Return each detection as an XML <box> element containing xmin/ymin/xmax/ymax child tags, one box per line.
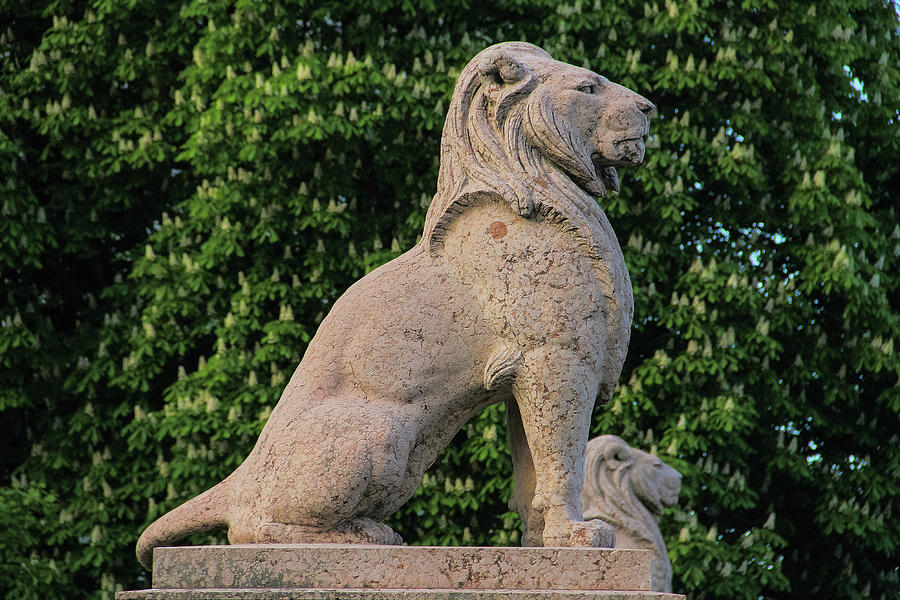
<box><xmin>116</xmin><ymin>544</ymin><xmax>684</xmax><ymax>600</ymax></box>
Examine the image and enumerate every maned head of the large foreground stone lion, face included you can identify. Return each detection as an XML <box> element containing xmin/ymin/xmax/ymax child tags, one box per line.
<box><xmin>423</xmin><ymin>42</ymin><xmax>655</xmax><ymax>253</ymax></box>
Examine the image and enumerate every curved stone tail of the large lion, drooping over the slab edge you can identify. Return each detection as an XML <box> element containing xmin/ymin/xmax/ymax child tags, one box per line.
<box><xmin>136</xmin><ymin>479</ymin><xmax>228</xmax><ymax>569</ymax></box>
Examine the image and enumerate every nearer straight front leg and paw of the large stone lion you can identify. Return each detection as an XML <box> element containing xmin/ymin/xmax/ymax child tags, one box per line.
<box><xmin>513</xmin><ymin>347</ymin><xmax>615</xmax><ymax>547</ymax></box>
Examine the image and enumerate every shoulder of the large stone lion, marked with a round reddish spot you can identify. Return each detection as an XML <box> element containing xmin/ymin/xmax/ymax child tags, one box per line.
<box><xmin>443</xmin><ymin>204</ymin><xmax>621</xmax><ymax>362</ymax></box>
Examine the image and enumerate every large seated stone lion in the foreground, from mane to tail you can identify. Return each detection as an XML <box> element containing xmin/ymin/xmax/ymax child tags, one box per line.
<box><xmin>137</xmin><ymin>42</ymin><xmax>654</xmax><ymax>566</ymax></box>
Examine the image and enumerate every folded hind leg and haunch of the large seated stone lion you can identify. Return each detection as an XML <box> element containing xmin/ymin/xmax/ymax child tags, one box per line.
<box><xmin>228</xmin><ymin>398</ymin><xmax>415</xmax><ymax>544</ymax></box>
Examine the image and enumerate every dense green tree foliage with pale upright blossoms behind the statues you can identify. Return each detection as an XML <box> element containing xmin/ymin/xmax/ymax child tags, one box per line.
<box><xmin>0</xmin><ymin>0</ymin><xmax>900</xmax><ymax>599</ymax></box>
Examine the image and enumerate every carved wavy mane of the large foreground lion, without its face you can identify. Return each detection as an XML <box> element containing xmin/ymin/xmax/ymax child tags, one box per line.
<box><xmin>423</xmin><ymin>42</ymin><xmax>630</xmax><ymax>274</ymax></box>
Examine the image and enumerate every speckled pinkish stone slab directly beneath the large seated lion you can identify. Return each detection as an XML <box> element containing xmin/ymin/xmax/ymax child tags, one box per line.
<box><xmin>153</xmin><ymin>544</ymin><xmax>652</xmax><ymax>591</ymax></box>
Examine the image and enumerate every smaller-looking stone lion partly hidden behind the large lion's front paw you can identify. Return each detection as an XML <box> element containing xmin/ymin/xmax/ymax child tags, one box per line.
<box><xmin>581</xmin><ymin>435</ymin><xmax>681</xmax><ymax>592</ymax></box>
